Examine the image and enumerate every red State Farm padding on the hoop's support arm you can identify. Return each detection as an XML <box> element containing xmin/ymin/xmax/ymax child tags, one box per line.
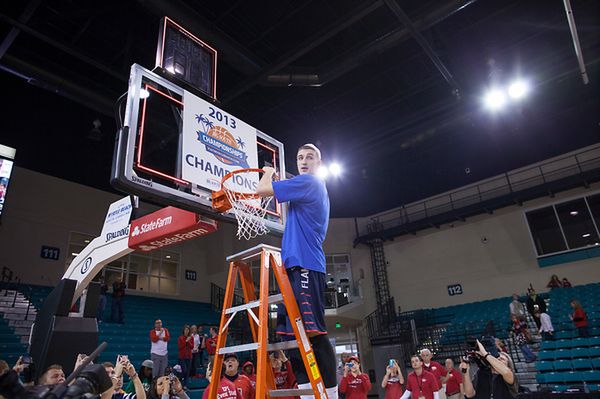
<box><xmin>128</xmin><ymin>206</ymin><xmax>218</xmax><ymax>252</ymax></box>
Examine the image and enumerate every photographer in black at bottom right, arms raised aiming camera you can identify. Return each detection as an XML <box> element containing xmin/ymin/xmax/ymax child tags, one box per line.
<box><xmin>460</xmin><ymin>340</ymin><xmax>519</xmax><ymax>399</ymax></box>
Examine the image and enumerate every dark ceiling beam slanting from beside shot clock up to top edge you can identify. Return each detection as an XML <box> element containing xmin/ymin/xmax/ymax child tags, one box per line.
<box><xmin>223</xmin><ymin>0</ymin><xmax>383</xmax><ymax>102</ymax></box>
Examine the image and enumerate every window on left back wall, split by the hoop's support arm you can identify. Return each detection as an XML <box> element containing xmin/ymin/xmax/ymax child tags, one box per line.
<box><xmin>67</xmin><ymin>233</ymin><xmax>180</xmax><ymax>295</ymax></box>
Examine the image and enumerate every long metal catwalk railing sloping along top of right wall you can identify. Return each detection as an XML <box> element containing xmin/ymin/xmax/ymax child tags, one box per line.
<box><xmin>357</xmin><ymin>144</ymin><xmax>600</xmax><ymax>236</ymax></box>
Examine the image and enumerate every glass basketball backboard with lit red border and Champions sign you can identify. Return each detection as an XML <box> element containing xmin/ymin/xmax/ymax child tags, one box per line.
<box><xmin>111</xmin><ymin>64</ymin><xmax>287</xmax><ymax>234</ymax></box>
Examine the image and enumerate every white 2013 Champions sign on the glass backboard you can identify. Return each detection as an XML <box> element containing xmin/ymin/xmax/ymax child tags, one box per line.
<box><xmin>181</xmin><ymin>91</ymin><xmax>259</xmax><ymax>192</ymax></box>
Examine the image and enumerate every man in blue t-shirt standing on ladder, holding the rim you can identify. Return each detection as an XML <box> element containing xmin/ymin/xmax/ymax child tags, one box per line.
<box><xmin>257</xmin><ymin>144</ymin><xmax>338</xmax><ymax>399</ymax></box>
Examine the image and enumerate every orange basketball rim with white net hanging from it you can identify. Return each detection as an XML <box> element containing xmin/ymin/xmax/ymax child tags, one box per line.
<box><xmin>221</xmin><ymin>168</ymin><xmax>273</xmax><ymax>240</ymax></box>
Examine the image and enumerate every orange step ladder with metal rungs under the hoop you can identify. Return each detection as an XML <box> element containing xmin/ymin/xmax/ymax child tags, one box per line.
<box><xmin>208</xmin><ymin>244</ymin><xmax>327</xmax><ymax>399</ymax></box>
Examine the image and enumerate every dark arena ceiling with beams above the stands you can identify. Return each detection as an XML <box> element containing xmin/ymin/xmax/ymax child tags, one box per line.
<box><xmin>0</xmin><ymin>0</ymin><xmax>600</xmax><ymax>217</ymax></box>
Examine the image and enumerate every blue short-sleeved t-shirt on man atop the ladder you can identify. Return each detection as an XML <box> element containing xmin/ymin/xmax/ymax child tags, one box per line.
<box><xmin>273</xmin><ymin>174</ymin><xmax>329</xmax><ymax>273</ymax></box>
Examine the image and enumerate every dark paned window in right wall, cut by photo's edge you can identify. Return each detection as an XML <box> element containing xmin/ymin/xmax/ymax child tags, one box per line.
<box><xmin>526</xmin><ymin>194</ymin><xmax>600</xmax><ymax>256</ymax></box>
